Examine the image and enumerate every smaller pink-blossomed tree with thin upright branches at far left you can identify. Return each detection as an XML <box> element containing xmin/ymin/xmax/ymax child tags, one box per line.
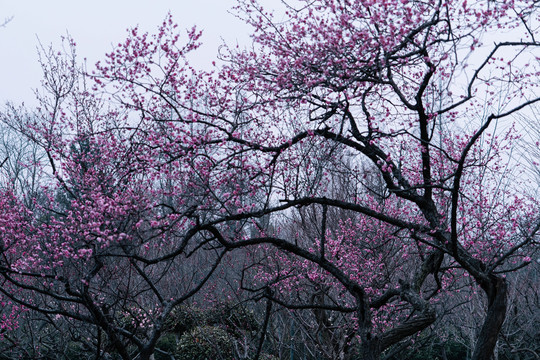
<box><xmin>0</xmin><ymin>40</ymin><xmax>236</xmax><ymax>359</ymax></box>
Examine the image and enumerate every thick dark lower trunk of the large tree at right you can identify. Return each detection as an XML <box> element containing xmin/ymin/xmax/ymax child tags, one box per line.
<box><xmin>472</xmin><ymin>276</ymin><xmax>508</xmax><ymax>360</ymax></box>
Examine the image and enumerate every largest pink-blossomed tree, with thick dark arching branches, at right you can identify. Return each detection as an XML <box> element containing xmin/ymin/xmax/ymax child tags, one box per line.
<box><xmin>215</xmin><ymin>1</ymin><xmax>539</xmax><ymax>359</ymax></box>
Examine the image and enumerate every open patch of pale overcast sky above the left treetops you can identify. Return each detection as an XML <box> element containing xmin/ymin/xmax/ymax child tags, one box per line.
<box><xmin>0</xmin><ymin>0</ymin><xmax>253</xmax><ymax>105</ymax></box>
